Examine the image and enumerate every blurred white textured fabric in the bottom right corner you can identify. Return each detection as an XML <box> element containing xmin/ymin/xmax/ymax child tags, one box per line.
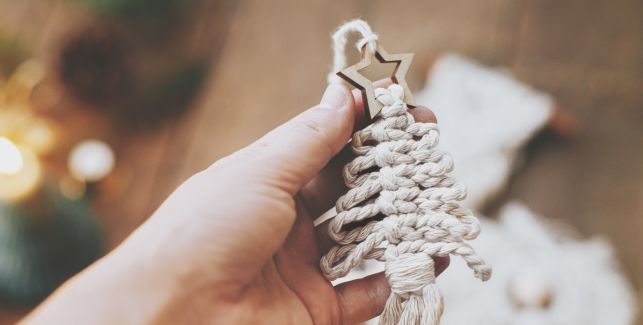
<box><xmin>437</xmin><ymin>202</ymin><xmax>639</xmax><ymax>325</ymax></box>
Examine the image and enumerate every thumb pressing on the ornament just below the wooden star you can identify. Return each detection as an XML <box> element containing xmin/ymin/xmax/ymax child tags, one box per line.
<box><xmin>224</xmin><ymin>84</ymin><xmax>355</xmax><ymax>195</ymax></box>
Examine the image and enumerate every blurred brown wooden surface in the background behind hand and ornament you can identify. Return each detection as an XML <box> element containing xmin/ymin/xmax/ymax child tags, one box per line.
<box><xmin>0</xmin><ymin>0</ymin><xmax>643</xmax><ymax>324</ymax></box>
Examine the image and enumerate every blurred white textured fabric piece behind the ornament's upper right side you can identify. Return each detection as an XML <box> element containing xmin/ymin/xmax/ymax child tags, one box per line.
<box><xmin>414</xmin><ymin>54</ymin><xmax>554</xmax><ymax>210</ymax></box>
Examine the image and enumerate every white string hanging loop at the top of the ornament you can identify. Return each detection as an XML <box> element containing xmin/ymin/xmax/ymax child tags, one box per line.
<box><xmin>328</xmin><ymin>19</ymin><xmax>377</xmax><ymax>84</ymax></box>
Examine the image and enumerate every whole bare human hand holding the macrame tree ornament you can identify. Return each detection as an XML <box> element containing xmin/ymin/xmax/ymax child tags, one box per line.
<box><xmin>27</xmin><ymin>81</ymin><xmax>449</xmax><ymax>324</ymax></box>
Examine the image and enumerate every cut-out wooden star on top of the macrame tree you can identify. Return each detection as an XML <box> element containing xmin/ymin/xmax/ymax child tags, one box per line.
<box><xmin>337</xmin><ymin>45</ymin><xmax>415</xmax><ymax>120</ymax></box>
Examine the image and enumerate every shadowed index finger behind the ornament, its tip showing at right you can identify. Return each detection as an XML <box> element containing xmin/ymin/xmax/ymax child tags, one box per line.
<box><xmin>300</xmin><ymin>105</ymin><xmax>436</xmax><ymax>218</ymax></box>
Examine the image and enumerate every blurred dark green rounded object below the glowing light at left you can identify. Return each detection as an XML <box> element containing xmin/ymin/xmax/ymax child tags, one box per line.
<box><xmin>0</xmin><ymin>190</ymin><xmax>104</xmax><ymax>307</ymax></box>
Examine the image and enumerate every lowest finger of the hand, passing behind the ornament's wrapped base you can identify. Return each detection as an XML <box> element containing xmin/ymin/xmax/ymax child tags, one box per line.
<box><xmin>335</xmin><ymin>257</ymin><xmax>450</xmax><ymax>324</ymax></box>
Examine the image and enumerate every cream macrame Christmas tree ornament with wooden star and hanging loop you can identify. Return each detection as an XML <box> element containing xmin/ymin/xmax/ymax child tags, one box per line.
<box><xmin>316</xmin><ymin>20</ymin><xmax>491</xmax><ymax>325</ymax></box>
